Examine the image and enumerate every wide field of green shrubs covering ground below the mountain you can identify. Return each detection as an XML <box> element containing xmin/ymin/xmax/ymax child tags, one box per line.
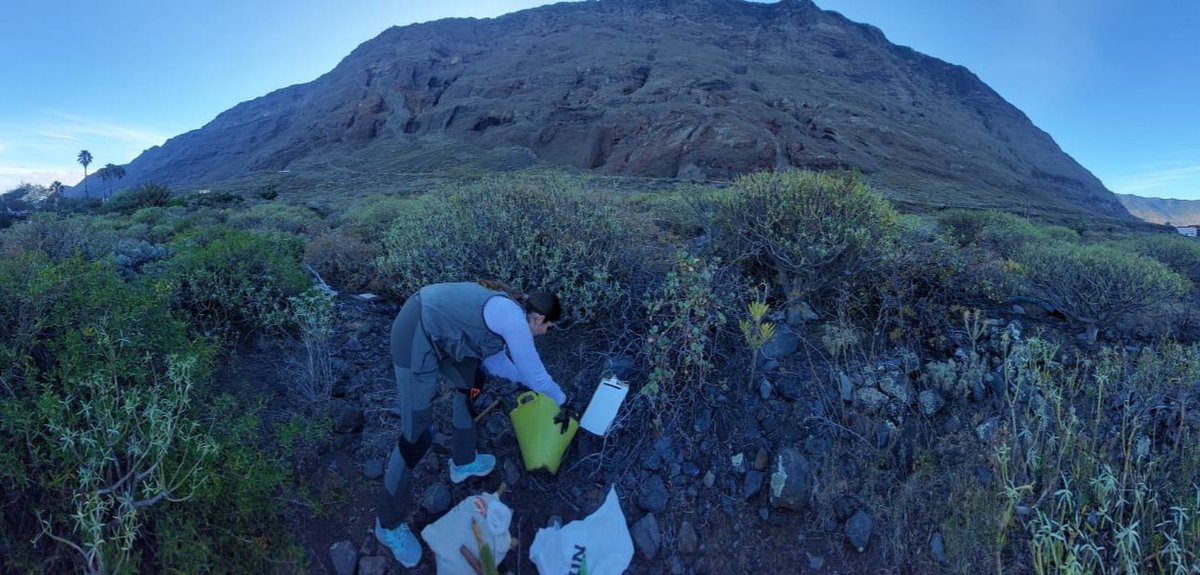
<box><xmin>0</xmin><ymin>172</ymin><xmax>1200</xmax><ymax>574</ymax></box>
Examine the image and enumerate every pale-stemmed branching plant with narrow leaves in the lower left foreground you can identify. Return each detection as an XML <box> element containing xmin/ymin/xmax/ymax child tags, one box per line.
<box><xmin>38</xmin><ymin>350</ymin><xmax>217</xmax><ymax>574</ymax></box>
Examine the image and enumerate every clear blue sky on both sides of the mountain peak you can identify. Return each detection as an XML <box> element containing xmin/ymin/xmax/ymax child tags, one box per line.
<box><xmin>0</xmin><ymin>0</ymin><xmax>1200</xmax><ymax>199</ymax></box>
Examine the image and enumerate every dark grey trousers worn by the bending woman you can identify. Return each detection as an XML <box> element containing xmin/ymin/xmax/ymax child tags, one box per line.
<box><xmin>377</xmin><ymin>295</ymin><xmax>479</xmax><ymax>529</ymax></box>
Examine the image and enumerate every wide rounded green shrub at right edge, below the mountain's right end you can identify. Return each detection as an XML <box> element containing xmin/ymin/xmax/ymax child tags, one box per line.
<box><xmin>1018</xmin><ymin>242</ymin><xmax>1192</xmax><ymax>341</ymax></box>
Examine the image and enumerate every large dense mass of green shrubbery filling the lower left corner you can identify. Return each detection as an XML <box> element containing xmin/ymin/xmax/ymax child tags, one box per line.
<box><xmin>0</xmin><ymin>252</ymin><xmax>211</xmax><ymax>569</ymax></box>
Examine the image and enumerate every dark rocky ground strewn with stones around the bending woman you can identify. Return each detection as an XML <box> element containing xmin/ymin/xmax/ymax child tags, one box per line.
<box><xmin>255</xmin><ymin>295</ymin><xmax>1041</xmax><ymax>575</ymax></box>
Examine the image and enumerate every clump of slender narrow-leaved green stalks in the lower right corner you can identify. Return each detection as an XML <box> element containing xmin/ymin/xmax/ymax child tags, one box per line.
<box><xmin>997</xmin><ymin>339</ymin><xmax>1200</xmax><ymax>574</ymax></box>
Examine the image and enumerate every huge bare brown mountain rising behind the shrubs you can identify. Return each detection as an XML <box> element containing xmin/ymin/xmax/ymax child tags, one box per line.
<box><xmin>77</xmin><ymin>0</ymin><xmax>1129</xmax><ymax>220</ymax></box>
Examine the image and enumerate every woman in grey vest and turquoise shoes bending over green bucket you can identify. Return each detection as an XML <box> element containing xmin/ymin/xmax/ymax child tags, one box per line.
<box><xmin>374</xmin><ymin>281</ymin><xmax>566</xmax><ymax>568</ymax></box>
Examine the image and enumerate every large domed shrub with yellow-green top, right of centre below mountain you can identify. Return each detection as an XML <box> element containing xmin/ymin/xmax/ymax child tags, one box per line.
<box><xmin>712</xmin><ymin>172</ymin><xmax>896</xmax><ymax>312</ymax></box>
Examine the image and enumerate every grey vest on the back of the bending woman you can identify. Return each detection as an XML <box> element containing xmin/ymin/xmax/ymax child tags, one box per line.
<box><xmin>420</xmin><ymin>282</ymin><xmax>508</xmax><ymax>363</ymax></box>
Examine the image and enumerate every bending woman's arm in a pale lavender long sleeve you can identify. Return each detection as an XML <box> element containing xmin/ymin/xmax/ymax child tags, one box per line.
<box><xmin>484</xmin><ymin>298</ymin><xmax>566</xmax><ymax>406</ymax></box>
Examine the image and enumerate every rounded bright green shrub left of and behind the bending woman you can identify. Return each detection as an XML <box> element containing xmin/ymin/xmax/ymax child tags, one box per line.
<box><xmin>166</xmin><ymin>226</ymin><xmax>311</xmax><ymax>337</ymax></box>
